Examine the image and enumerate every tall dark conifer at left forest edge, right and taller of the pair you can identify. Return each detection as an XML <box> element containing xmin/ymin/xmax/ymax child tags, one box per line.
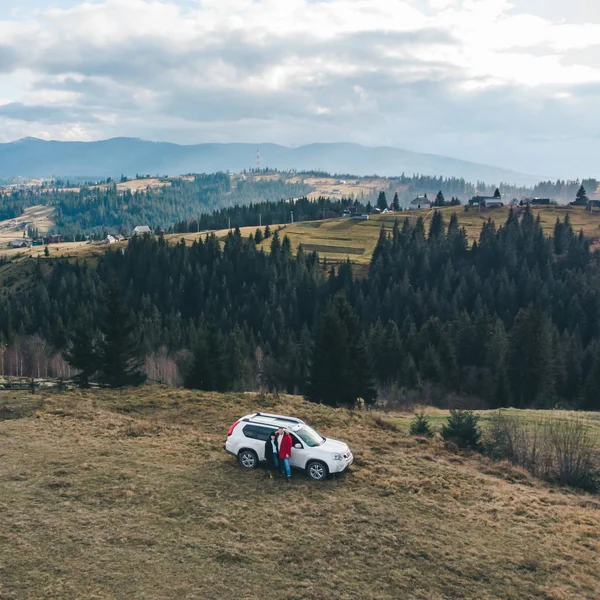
<box><xmin>99</xmin><ymin>278</ymin><xmax>146</xmax><ymax>388</ymax></box>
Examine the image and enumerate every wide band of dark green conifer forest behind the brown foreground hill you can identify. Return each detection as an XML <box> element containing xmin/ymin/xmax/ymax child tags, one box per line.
<box><xmin>0</xmin><ymin>208</ymin><xmax>600</xmax><ymax>409</ymax></box>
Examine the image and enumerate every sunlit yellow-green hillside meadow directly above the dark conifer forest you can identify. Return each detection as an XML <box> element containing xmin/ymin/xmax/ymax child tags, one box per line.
<box><xmin>263</xmin><ymin>206</ymin><xmax>600</xmax><ymax>265</ymax></box>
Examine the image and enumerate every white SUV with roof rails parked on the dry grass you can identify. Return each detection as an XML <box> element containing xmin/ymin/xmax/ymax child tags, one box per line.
<box><xmin>225</xmin><ymin>413</ymin><xmax>354</xmax><ymax>481</ymax></box>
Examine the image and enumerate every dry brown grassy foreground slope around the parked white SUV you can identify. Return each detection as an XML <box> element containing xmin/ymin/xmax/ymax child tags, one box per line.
<box><xmin>0</xmin><ymin>388</ymin><xmax>600</xmax><ymax>600</ymax></box>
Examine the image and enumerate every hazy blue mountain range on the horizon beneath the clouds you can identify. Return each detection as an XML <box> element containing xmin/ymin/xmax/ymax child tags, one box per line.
<box><xmin>0</xmin><ymin>138</ymin><xmax>539</xmax><ymax>185</ymax></box>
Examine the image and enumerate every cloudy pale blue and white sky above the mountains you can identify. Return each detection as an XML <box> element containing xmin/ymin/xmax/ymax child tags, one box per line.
<box><xmin>0</xmin><ymin>0</ymin><xmax>600</xmax><ymax>177</ymax></box>
